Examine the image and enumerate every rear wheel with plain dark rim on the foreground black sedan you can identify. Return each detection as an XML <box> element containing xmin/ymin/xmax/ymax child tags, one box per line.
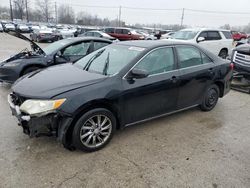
<box><xmin>200</xmin><ymin>84</ymin><xmax>220</xmax><ymax>111</ymax></box>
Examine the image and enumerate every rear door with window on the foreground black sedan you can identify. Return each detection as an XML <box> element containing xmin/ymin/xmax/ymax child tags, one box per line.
<box><xmin>176</xmin><ymin>45</ymin><xmax>215</xmax><ymax>109</ymax></box>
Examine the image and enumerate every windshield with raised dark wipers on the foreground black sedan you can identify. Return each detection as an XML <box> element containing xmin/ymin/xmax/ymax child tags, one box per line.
<box><xmin>74</xmin><ymin>45</ymin><xmax>145</xmax><ymax>75</ymax></box>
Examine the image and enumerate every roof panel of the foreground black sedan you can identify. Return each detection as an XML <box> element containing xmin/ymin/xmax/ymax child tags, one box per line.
<box><xmin>117</xmin><ymin>39</ymin><xmax>191</xmax><ymax>48</ymax></box>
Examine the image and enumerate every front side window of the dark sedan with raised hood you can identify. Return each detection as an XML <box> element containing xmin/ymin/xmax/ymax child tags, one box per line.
<box><xmin>63</xmin><ymin>42</ymin><xmax>91</xmax><ymax>56</ymax></box>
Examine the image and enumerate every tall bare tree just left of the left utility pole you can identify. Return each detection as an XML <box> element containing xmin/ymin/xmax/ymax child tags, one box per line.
<box><xmin>36</xmin><ymin>0</ymin><xmax>52</xmax><ymax>22</ymax></box>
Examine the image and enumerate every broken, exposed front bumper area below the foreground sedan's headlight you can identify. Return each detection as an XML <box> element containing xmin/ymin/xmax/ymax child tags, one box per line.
<box><xmin>8</xmin><ymin>95</ymin><xmax>73</xmax><ymax>144</ymax></box>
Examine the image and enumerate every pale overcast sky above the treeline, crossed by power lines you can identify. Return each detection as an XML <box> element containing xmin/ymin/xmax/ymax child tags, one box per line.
<box><xmin>0</xmin><ymin>0</ymin><xmax>250</xmax><ymax>27</ymax></box>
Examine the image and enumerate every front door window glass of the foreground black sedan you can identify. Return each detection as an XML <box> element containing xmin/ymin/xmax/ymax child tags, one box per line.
<box><xmin>135</xmin><ymin>47</ymin><xmax>175</xmax><ymax>75</ymax></box>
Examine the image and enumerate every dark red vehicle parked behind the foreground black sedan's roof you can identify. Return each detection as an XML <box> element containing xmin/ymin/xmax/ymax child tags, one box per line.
<box><xmin>104</xmin><ymin>27</ymin><xmax>145</xmax><ymax>41</ymax></box>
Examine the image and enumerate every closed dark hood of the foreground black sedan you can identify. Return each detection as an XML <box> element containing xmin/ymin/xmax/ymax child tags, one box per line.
<box><xmin>12</xmin><ymin>63</ymin><xmax>107</xmax><ymax>99</ymax></box>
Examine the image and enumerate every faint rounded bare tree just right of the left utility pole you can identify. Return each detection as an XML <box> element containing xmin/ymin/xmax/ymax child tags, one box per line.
<box><xmin>58</xmin><ymin>5</ymin><xmax>75</xmax><ymax>24</ymax></box>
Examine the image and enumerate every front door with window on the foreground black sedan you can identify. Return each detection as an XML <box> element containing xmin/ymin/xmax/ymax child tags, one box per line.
<box><xmin>123</xmin><ymin>47</ymin><xmax>179</xmax><ymax>124</ymax></box>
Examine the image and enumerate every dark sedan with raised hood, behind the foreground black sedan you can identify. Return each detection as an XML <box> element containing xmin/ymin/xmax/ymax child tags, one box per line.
<box><xmin>0</xmin><ymin>32</ymin><xmax>112</xmax><ymax>83</ymax></box>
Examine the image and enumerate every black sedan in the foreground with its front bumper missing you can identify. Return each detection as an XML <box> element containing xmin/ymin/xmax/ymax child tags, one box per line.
<box><xmin>8</xmin><ymin>41</ymin><xmax>233</xmax><ymax>151</ymax></box>
